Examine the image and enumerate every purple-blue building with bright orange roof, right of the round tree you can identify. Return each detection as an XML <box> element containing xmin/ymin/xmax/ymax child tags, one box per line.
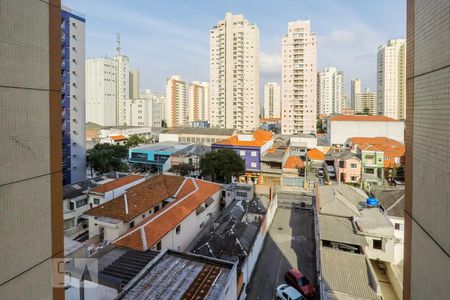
<box><xmin>211</xmin><ymin>129</ymin><xmax>273</xmax><ymax>183</ymax></box>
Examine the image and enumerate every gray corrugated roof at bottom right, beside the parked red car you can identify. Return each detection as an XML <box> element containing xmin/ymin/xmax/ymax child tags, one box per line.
<box><xmin>320</xmin><ymin>248</ymin><xmax>379</xmax><ymax>299</ymax></box>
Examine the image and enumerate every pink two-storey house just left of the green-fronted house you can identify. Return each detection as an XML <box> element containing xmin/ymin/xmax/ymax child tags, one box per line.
<box><xmin>334</xmin><ymin>151</ymin><xmax>361</xmax><ymax>183</ymax></box>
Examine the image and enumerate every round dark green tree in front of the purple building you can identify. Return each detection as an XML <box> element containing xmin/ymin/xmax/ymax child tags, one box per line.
<box><xmin>200</xmin><ymin>149</ymin><xmax>245</xmax><ymax>183</ymax></box>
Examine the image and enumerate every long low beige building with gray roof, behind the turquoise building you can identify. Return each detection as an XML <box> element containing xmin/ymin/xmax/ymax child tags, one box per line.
<box><xmin>159</xmin><ymin>127</ymin><xmax>236</xmax><ymax>146</ymax></box>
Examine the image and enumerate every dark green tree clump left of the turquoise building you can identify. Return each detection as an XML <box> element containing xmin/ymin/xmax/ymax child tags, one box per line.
<box><xmin>87</xmin><ymin>143</ymin><xmax>128</xmax><ymax>173</ymax></box>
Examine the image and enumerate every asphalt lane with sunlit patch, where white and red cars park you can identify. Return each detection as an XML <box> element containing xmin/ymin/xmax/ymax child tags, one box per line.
<box><xmin>247</xmin><ymin>207</ymin><xmax>319</xmax><ymax>300</ymax></box>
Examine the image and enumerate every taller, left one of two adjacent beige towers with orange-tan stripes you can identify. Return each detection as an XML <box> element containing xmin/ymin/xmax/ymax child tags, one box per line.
<box><xmin>164</xmin><ymin>75</ymin><xmax>188</xmax><ymax>127</ymax></box>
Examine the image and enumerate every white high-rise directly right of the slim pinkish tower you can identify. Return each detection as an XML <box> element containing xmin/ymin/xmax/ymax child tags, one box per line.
<box><xmin>317</xmin><ymin>68</ymin><xmax>345</xmax><ymax>115</ymax></box>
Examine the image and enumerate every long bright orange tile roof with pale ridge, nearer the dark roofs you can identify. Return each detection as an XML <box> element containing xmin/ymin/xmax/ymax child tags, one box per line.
<box><xmin>113</xmin><ymin>178</ymin><xmax>222</xmax><ymax>251</ymax></box>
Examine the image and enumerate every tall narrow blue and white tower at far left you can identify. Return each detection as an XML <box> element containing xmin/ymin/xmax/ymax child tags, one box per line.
<box><xmin>61</xmin><ymin>7</ymin><xmax>86</xmax><ymax>185</ymax></box>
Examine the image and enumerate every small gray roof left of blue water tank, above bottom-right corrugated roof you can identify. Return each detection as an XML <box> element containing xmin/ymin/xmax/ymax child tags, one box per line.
<box><xmin>319</xmin><ymin>215</ymin><xmax>366</xmax><ymax>246</ymax></box>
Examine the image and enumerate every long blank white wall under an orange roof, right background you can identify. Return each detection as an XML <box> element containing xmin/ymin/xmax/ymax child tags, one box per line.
<box><xmin>327</xmin><ymin>120</ymin><xmax>405</xmax><ymax>145</ymax></box>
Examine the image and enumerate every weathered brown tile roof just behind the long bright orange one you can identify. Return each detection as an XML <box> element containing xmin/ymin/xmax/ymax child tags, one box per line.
<box><xmin>85</xmin><ymin>175</ymin><xmax>184</xmax><ymax>222</ymax></box>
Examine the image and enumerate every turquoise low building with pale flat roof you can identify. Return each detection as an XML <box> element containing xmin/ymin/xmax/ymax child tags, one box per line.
<box><xmin>128</xmin><ymin>141</ymin><xmax>189</xmax><ymax>172</ymax></box>
